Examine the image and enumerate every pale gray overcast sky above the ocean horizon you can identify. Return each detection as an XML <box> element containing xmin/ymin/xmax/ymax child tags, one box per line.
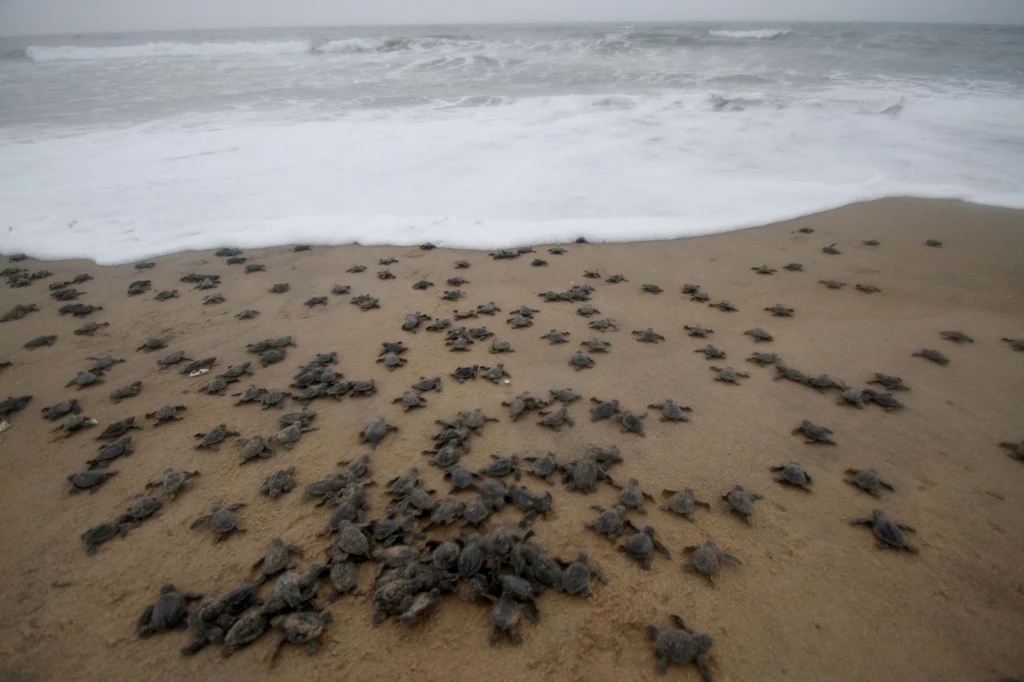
<box><xmin>0</xmin><ymin>0</ymin><xmax>1024</xmax><ymax>35</ymax></box>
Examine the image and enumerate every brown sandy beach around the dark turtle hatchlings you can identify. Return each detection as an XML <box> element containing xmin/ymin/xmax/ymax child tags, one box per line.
<box><xmin>0</xmin><ymin>200</ymin><xmax>1024</xmax><ymax>681</ymax></box>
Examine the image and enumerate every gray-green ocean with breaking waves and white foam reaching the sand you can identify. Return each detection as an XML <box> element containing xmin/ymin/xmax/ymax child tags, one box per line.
<box><xmin>0</xmin><ymin>24</ymin><xmax>1024</xmax><ymax>263</ymax></box>
